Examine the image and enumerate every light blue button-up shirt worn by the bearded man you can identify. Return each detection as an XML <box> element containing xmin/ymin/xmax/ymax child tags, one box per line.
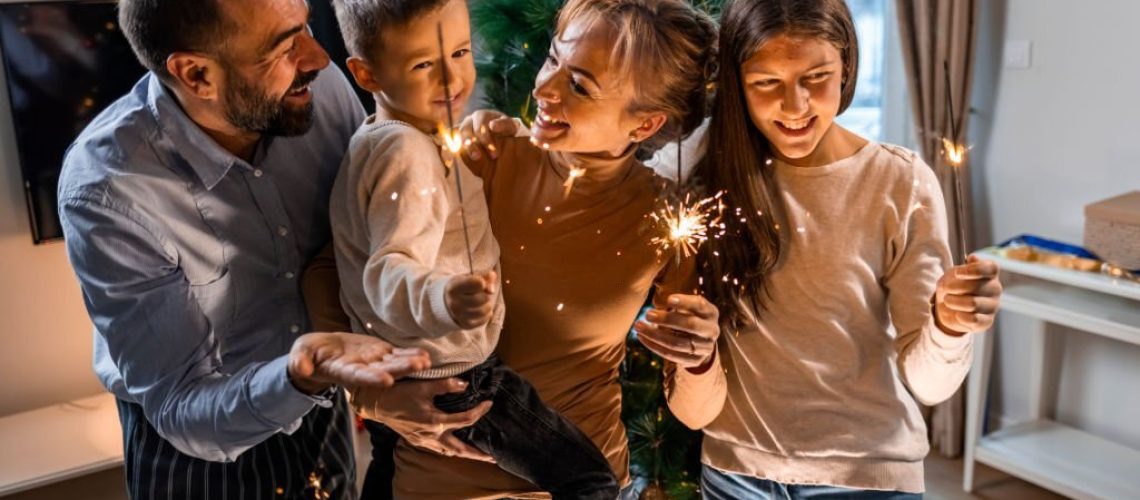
<box><xmin>59</xmin><ymin>67</ymin><xmax>364</xmax><ymax>461</ymax></box>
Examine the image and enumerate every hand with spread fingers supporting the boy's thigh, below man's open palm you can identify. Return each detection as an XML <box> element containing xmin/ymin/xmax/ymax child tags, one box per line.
<box><xmin>349</xmin><ymin>378</ymin><xmax>495</xmax><ymax>462</ymax></box>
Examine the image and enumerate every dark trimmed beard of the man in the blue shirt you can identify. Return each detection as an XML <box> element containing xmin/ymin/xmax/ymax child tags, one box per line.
<box><xmin>223</xmin><ymin>68</ymin><xmax>320</xmax><ymax>137</ymax></box>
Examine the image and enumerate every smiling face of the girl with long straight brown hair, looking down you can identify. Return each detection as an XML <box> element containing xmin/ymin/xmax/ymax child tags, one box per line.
<box><xmin>740</xmin><ymin>34</ymin><xmax>844</xmax><ymax>164</ymax></box>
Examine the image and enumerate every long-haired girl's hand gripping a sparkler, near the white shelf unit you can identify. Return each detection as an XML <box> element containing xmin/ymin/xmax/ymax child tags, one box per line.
<box><xmin>934</xmin><ymin>255</ymin><xmax>1002</xmax><ymax>336</ymax></box>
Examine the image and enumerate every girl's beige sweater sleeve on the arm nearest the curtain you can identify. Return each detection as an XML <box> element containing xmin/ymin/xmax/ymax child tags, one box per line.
<box><xmin>884</xmin><ymin>158</ymin><xmax>972</xmax><ymax>404</ymax></box>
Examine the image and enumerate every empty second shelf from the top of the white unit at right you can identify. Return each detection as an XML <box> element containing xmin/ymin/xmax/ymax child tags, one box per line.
<box><xmin>1001</xmin><ymin>281</ymin><xmax>1140</xmax><ymax>345</ymax></box>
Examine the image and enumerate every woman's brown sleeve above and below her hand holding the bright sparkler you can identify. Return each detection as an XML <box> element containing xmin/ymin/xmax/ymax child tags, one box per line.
<box><xmin>653</xmin><ymin>254</ymin><xmax>728</xmax><ymax>429</ymax></box>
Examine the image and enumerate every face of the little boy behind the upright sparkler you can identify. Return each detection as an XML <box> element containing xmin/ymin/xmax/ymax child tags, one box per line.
<box><xmin>369</xmin><ymin>0</ymin><xmax>475</xmax><ymax>131</ymax></box>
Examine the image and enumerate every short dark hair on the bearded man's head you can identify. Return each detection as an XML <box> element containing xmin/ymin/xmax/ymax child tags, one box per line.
<box><xmin>119</xmin><ymin>0</ymin><xmax>229</xmax><ymax>80</ymax></box>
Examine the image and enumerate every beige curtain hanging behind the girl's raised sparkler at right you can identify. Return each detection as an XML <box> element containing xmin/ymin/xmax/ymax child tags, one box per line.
<box><xmin>896</xmin><ymin>0</ymin><xmax>978</xmax><ymax>457</ymax></box>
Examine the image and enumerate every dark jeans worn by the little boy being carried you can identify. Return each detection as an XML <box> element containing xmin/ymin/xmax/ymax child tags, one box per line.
<box><xmin>361</xmin><ymin>356</ymin><xmax>620</xmax><ymax>500</ymax></box>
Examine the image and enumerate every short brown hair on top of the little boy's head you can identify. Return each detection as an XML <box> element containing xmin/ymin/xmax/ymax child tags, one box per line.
<box><xmin>333</xmin><ymin>0</ymin><xmax>450</xmax><ymax>63</ymax></box>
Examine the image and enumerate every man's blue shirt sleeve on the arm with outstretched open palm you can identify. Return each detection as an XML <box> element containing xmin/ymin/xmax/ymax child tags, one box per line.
<box><xmin>60</xmin><ymin>194</ymin><xmax>329</xmax><ymax>461</ymax></box>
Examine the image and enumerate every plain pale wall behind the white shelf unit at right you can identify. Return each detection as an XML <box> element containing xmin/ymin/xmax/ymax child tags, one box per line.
<box><xmin>971</xmin><ymin>0</ymin><xmax>1140</xmax><ymax>449</ymax></box>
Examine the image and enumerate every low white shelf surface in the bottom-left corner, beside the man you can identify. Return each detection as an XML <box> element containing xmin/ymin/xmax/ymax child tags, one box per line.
<box><xmin>0</xmin><ymin>394</ymin><xmax>123</xmax><ymax>497</ymax></box>
